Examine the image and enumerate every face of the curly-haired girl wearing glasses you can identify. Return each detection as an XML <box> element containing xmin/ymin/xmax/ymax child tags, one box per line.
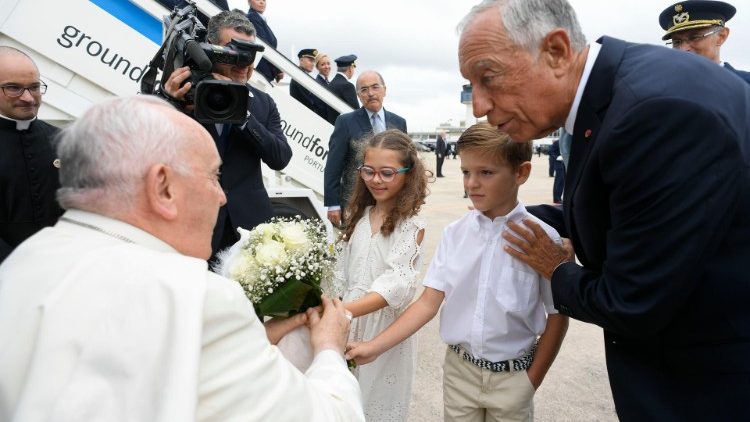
<box><xmin>363</xmin><ymin>148</ymin><xmax>408</xmax><ymax>209</ymax></box>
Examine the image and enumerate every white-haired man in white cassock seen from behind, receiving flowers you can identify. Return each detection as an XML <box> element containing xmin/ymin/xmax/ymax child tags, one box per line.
<box><xmin>0</xmin><ymin>96</ymin><xmax>364</xmax><ymax>422</ymax></box>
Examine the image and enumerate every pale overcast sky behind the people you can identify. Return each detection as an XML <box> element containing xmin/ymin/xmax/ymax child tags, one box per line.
<box><xmin>229</xmin><ymin>0</ymin><xmax>750</xmax><ymax>131</ymax></box>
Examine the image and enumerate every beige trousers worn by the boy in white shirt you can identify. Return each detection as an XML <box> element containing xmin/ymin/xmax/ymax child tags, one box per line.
<box><xmin>443</xmin><ymin>349</ymin><xmax>535</xmax><ymax>422</ymax></box>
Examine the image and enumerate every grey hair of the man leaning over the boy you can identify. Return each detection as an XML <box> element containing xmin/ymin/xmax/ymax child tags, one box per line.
<box><xmin>458</xmin><ymin>0</ymin><xmax>586</xmax><ymax>55</ymax></box>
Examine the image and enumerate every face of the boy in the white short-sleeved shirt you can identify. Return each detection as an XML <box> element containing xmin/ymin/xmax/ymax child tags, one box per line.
<box><xmin>460</xmin><ymin>149</ymin><xmax>531</xmax><ymax>219</ymax></box>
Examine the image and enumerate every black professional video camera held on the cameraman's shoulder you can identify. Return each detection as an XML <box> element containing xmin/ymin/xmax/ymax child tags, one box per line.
<box><xmin>141</xmin><ymin>0</ymin><xmax>264</xmax><ymax>123</ymax></box>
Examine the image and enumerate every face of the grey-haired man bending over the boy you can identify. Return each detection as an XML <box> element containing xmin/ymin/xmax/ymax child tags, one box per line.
<box><xmin>458</xmin><ymin>8</ymin><xmax>575</xmax><ymax>141</ymax></box>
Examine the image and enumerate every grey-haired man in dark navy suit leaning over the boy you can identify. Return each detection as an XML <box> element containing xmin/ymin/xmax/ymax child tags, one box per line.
<box><xmin>459</xmin><ymin>0</ymin><xmax>750</xmax><ymax>421</ymax></box>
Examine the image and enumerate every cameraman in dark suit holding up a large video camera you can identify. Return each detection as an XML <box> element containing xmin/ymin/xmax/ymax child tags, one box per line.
<box><xmin>161</xmin><ymin>10</ymin><xmax>292</xmax><ymax>256</ymax></box>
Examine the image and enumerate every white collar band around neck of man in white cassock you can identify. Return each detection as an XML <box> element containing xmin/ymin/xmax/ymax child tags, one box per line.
<box><xmin>58</xmin><ymin>209</ymin><xmax>179</xmax><ymax>253</ymax></box>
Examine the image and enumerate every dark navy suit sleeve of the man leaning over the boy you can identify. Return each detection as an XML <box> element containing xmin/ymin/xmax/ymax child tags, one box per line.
<box><xmin>552</xmin><ymin>99</ymin><xmax>743</xmax><ymax>338</ymax></box>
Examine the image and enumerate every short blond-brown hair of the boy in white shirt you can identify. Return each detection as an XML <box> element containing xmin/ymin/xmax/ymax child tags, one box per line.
<box><xmin>458</xmin><ymin>122</ymin><xmax>532</xmax><ymax>171</ymax></box>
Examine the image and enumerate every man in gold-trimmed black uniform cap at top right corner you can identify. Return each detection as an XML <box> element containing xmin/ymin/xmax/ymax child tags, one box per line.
<box><xmin>659</xmin><ymin>0</ymin><xmax>750</xmax><ymax>83</ymax></box>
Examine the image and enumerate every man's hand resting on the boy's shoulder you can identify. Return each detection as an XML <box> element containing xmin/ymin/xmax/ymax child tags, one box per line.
<box><xmin>503</xmin><ymin>219</ymin><xmax>575</xmax><ymax>280</ymax></box>
